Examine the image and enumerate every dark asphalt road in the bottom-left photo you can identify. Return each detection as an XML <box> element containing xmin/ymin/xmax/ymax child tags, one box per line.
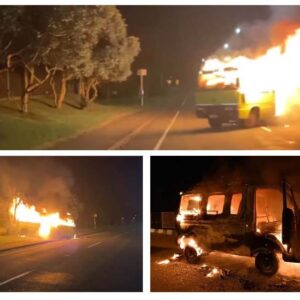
<box><xmin>0</xmin><ymin>225</ymin><xmax>143</xmax><ymax>292</ymax></box>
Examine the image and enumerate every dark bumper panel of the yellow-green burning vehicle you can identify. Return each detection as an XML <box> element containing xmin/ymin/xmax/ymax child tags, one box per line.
<box><xmin>196</xmin><ymin>104</ymin><xmax>239</xmax><ymax>123</ymax></box>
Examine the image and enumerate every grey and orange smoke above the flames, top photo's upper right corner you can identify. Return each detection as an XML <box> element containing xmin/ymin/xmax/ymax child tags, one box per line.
<box><xmin>214</xmin><ymin>6</ymin><xmax>300</xmax><ymax>58</ymax></box>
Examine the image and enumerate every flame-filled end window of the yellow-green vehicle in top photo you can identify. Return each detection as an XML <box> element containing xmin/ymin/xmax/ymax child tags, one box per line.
<box><xmin>199</xmin><ymin>67</ymin><xmax>239</xmax><ymax>90</ymax></box>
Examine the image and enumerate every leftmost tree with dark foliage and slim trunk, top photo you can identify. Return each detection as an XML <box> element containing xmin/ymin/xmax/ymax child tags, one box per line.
<box><xmin>0</xmin><ymin>6</ymin><xmax>58</xmax><ymax>113</ymax></box>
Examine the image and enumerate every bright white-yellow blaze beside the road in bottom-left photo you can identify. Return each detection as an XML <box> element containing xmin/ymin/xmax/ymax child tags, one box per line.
<box><xmin>9</xmin><ymin>198</ymin><xmax>75</xmax><ymax>239</ymax></box>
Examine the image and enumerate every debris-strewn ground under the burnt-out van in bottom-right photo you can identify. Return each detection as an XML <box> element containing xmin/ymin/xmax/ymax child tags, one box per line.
<box><xmin>151</xmin><ymin>233</ymin><xmax>300</xmax><ymax>292</ymax></box>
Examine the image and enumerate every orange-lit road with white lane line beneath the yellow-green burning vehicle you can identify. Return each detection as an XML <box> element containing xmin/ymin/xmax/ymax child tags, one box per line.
<box><xmin>51</xmin><ymin>96</ymin><xmax>300</xmax><ymax>150</ymax></box>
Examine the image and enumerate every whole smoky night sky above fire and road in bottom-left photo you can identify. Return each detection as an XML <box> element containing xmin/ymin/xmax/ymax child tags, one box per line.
<box><xmin>0</xmin><ymin>156</ymin><xmax>143</xmax><ymax>226</ymax></box>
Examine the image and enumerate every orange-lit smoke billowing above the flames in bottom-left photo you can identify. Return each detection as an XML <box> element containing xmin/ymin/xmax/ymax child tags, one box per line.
<box><xmin>0</xmin><ymin>157</ymin><xmax>76</xmax><ymax>214</ymax></box>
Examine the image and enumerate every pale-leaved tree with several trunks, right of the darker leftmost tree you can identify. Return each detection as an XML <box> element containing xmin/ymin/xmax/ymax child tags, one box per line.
<box><xmin>43</xmin><ymin>6</ymin><xmax>140</xmax><ymax>108</ymax></box>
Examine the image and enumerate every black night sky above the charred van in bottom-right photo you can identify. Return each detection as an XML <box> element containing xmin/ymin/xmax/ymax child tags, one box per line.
<box><xmin>151</xmin><ymin>156</ymin><xmax>300</xmax><ymax>212</ymax></box>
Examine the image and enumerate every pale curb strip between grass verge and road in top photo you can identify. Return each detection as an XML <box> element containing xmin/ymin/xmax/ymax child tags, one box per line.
<box><xmin>39</xmin><ymin>109</ymin><xmax>141</xmax><ymax>150</ymax></box>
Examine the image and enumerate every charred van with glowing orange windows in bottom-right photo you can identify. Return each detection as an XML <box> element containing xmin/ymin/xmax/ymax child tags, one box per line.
<box><xmin>177</xmin><ymin>181</ymin><xmax>300</xmax><ymax>275</ymax></box>
